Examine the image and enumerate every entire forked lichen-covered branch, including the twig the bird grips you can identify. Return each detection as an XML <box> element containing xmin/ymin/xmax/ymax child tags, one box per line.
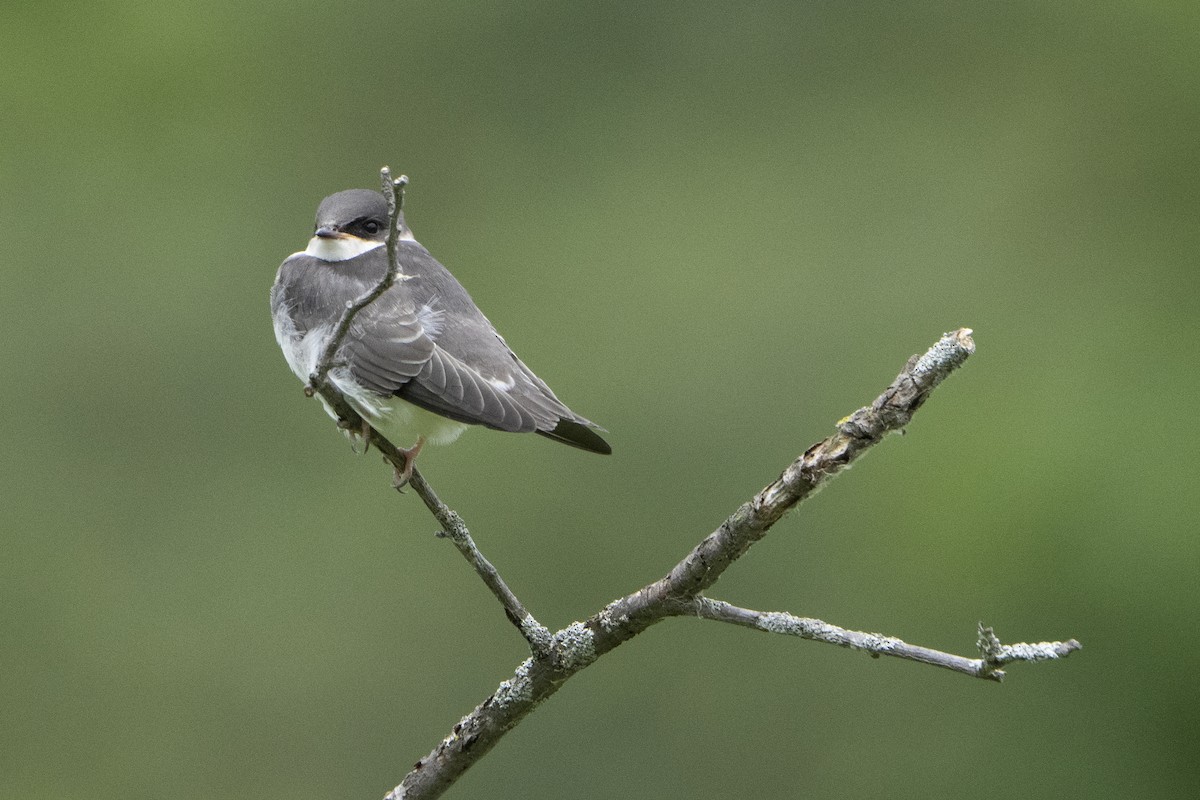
<box><xmin>290</xmin><ymin>167</ymin><xmax>1080</xmax><ymax>800</ymax></box>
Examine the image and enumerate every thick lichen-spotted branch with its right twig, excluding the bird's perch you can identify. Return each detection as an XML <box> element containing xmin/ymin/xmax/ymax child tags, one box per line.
<box><xmin>386</xmin><ymin>329</ymin><xmax>1060</xmax><ymax>800</ymax></box>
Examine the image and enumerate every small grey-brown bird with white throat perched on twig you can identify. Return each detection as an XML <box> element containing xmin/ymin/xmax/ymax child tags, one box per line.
<box><xmin>271</xmin><ymin>190</ymin><xmax>612</xmax><ymax>488</ymax></box>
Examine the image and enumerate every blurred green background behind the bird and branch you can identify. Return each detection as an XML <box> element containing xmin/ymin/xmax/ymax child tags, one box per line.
<box><xmin>0</xmin><ymin>0</ymin><xmax>1200</xmax><ymax>800</ymax></box>
